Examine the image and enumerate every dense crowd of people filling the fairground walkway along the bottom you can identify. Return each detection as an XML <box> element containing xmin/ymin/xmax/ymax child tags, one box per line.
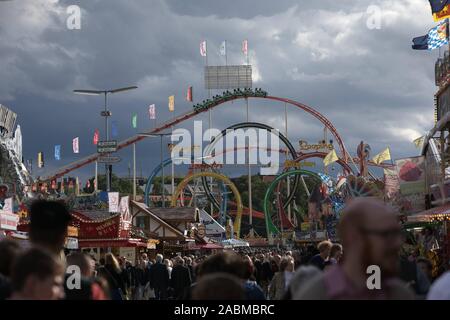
<box><xmin>0</xmin><ymin>199</ymin><xmax>450</xmax><ymax>300</ymax></box>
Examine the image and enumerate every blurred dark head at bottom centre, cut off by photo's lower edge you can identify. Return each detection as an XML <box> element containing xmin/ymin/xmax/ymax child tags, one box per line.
<box><xmin>192</xmin><ymin>272</ymin><xmax>245</xmax><ymax>301</ymax></box>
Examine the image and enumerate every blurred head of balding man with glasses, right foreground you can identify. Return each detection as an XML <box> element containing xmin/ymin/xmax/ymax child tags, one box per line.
<box><xmin>338</xmin><ymin>198</ymin><xmax>402</xmax><ymax>278</ymax></box>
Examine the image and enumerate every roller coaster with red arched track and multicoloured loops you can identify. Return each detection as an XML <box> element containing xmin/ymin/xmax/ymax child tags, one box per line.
<box><xmin>41</xmin><ymin>88</ymin><xmax>387</xmax><ymax>237</ymax></box>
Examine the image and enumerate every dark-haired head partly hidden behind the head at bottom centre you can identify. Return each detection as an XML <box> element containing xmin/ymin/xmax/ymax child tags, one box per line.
<box><xmin>198</xmin><ymin>251</ymin><xmax>245</xmax><ymax>279</ymax></box>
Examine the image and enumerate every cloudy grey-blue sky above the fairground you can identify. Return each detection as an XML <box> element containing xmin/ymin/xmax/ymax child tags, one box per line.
<box><xmin>0</xmin><ymin>0</ymin><xmax>439</xmax><ymax>178</ymax></box>
